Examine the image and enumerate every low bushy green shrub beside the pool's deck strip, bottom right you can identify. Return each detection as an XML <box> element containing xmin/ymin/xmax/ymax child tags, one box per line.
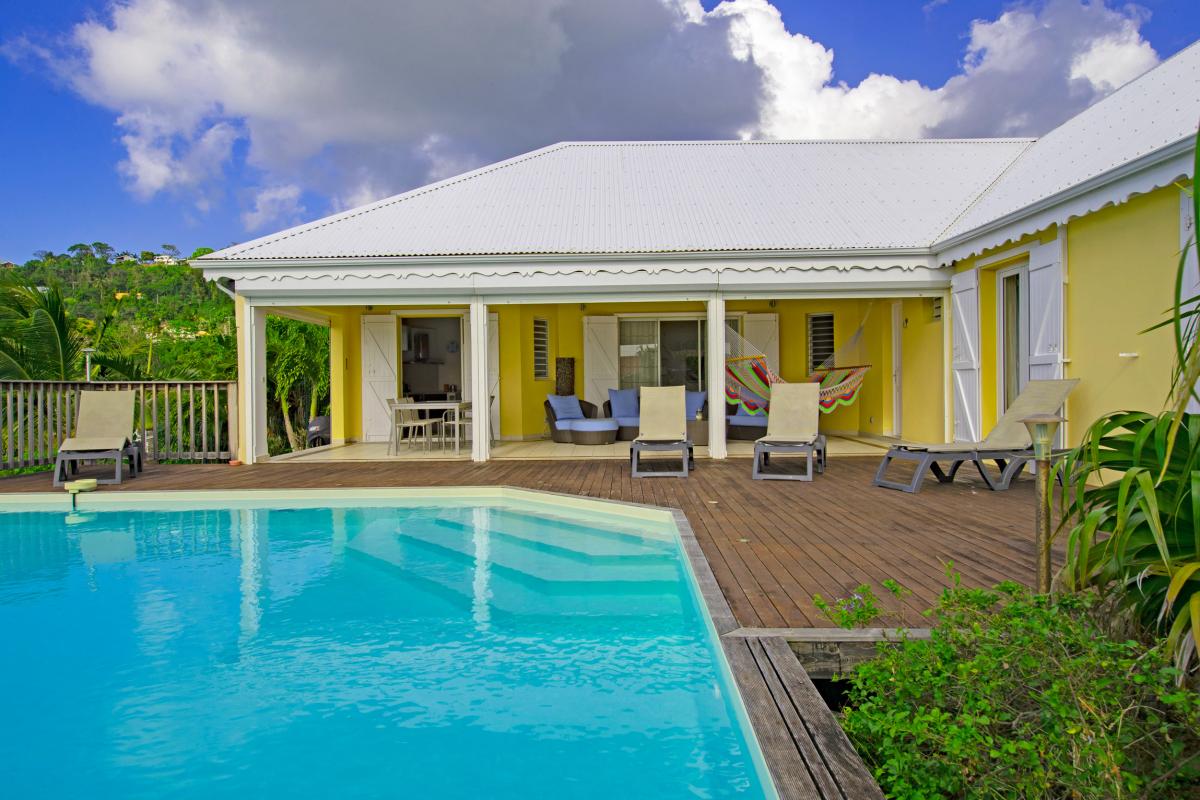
<box><xmin>842</xmin><ymin>584</ymin><xmax>1200</xmax><ymax>800</ymax></box>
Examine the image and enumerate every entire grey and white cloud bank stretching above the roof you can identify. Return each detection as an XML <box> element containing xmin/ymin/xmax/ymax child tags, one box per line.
<box><xmin>7</xmin><ymin>0</ymin><xmax>1157</xmax><ymax>229</ymax></box>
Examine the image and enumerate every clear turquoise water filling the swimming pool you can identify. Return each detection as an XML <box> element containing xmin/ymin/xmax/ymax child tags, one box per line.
<box><xmin>0</xmin><ymin>501</ymin><xmax>774</xmax><ymax>800</ymax></box>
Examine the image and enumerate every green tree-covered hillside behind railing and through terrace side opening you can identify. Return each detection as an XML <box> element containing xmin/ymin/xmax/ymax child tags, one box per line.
<box><xmin>0</xmin><ymin>242</ymin><xmax>329</xmax><ymax>452</ymax></box>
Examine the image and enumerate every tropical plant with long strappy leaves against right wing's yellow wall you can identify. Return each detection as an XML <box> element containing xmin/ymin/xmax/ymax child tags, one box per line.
<box><xmin>1056</xmin><ymin>130</ymin><xmax>1200</xmax><ymax>674</ymax></box>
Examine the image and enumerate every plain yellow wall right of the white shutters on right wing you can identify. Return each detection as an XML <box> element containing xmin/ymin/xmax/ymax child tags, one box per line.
<box><xmin>1066</xmin><ymin>187</ymin><xmax>1180</xmax><ymax>444</ymax></box>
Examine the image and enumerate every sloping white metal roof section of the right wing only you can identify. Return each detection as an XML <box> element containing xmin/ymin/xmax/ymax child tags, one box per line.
<box><xmin>940</xmin><ymin>42</ymin><xmax>1200</xmax><ymax>240</ymax></box>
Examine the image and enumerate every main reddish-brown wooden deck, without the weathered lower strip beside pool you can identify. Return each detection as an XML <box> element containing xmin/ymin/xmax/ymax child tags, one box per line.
<box><xmin>0</xmin><ymin>457</ymin><xmax>1051</xmax><ymax>628</ymax></box>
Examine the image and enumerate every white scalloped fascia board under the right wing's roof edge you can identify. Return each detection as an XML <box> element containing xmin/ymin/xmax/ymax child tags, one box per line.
<box><xmin>934</xmin><ymin>137</ymin><xmax>1195</xmax><ymax>264</ymax></box>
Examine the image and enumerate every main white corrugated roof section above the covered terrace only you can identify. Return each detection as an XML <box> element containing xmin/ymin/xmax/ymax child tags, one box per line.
<box><xmin>202</xmin><ymin>139</ymin><xmax>1030</xmax><ymax>261</ymax></box>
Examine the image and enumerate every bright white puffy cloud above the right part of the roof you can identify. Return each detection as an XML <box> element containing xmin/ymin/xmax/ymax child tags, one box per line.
<box><xmin>708</xmin><ymin>0</ymin><xmax>1158</xmax><ymax>138</ymax></box>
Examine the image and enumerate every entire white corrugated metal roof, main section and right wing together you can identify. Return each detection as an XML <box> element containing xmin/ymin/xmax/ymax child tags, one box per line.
<box><xmin>198</xmin><ymin>43</ymin><xmax>1200</xmax><ymax>266</ymax></box>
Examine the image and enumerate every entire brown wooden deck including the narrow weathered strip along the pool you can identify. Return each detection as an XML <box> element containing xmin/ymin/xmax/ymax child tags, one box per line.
<box><xmin>0</xmin><ymin>457</ymin><xmax>1033</xmax><ymax>800</ymax></box>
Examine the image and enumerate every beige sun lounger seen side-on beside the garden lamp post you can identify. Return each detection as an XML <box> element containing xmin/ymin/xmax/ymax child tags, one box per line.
<box><xmin>874</xmin><ymin>379</ymin><xmax>1079</xmax><ymax>493</ymax></box>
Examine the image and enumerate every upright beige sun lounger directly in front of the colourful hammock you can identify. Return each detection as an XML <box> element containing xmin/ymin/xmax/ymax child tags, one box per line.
<box><xmin>750</xmin><ymin>383</ymin><xmax>826</xmax><ymax>481</ymax></box>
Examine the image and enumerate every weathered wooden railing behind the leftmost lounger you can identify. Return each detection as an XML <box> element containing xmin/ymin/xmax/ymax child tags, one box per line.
<box><xmin>0</xmin><ymin>380</ymin><xmax>238</xmax><ymax>469</ymax></box>
